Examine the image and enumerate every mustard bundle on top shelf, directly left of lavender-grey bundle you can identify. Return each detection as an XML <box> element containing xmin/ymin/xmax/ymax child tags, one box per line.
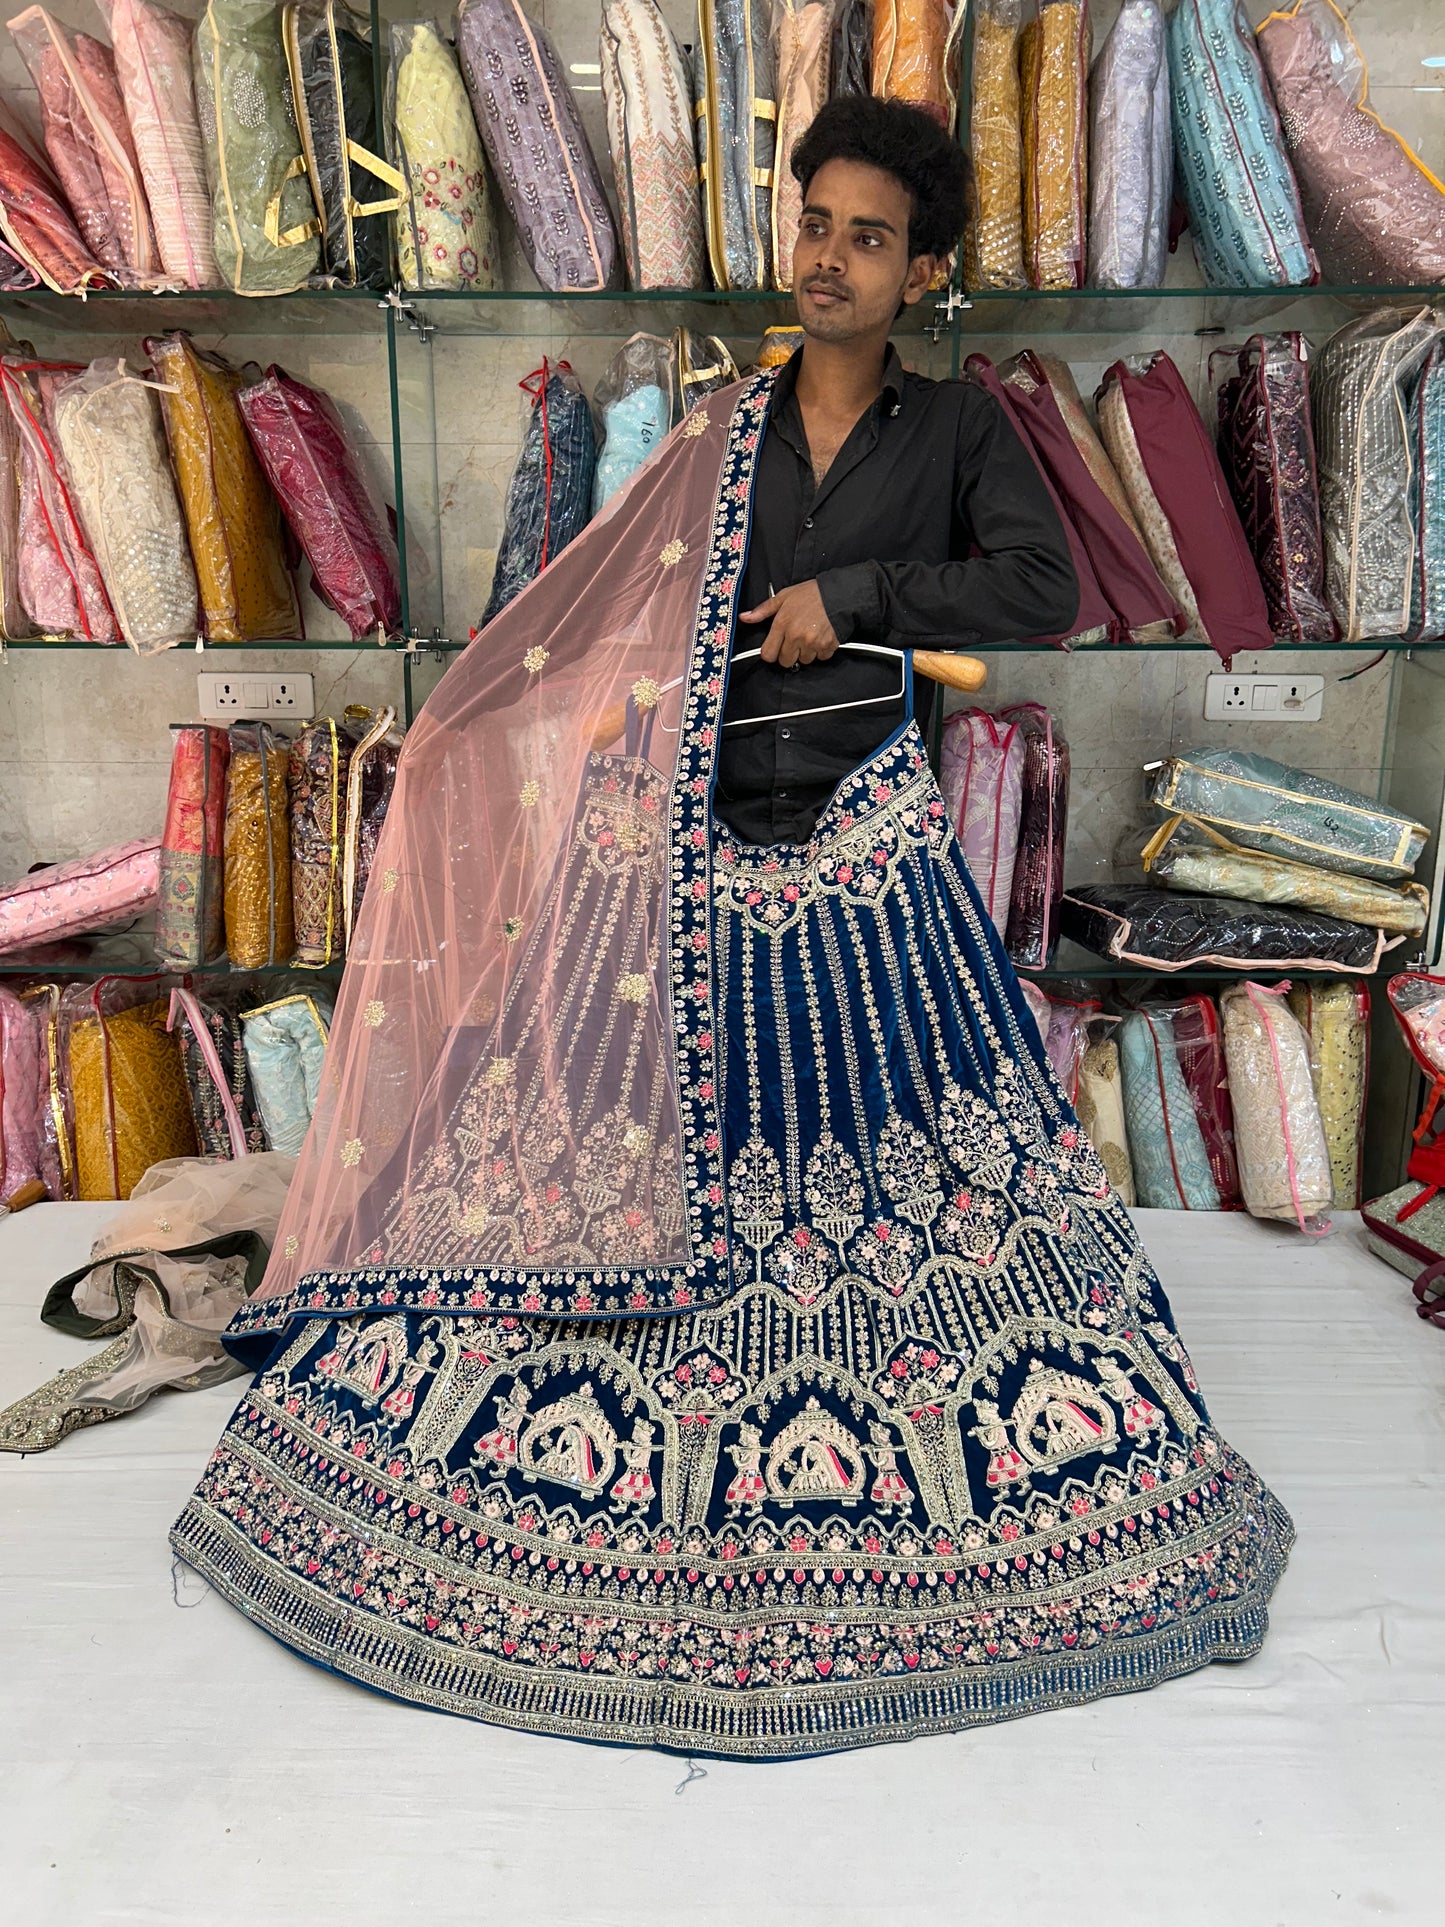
<box><xmin>1019</xmin><ymin>0</ymin><xmax>1089</xmax><ymax>287</ymax></box>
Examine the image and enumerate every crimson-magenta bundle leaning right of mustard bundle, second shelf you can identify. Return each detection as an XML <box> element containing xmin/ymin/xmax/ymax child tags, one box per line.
<box><xmin>237</xmin><ymin>368</ymin><xmax>401</xmax><ymax>642</ymax></box>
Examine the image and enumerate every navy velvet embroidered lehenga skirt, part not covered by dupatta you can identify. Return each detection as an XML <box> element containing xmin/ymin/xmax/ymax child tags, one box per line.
<box><xmin>173</xmin><ymin>725</ymin><xmax>1291</xmax><ymax>1759</ymax></box>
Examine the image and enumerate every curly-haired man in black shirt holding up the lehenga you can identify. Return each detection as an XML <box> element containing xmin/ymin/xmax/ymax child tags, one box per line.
<box><xmin>717</xmin><ymin>96</ymin><xmax>1079</xmax><ymax>844</ymax></box>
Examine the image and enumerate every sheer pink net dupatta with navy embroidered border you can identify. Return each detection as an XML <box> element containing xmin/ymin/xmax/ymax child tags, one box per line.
<box><xmin>231</xmin><ymin>374</ymin><xmax>773</xmax><ymax>1362</ymax></box>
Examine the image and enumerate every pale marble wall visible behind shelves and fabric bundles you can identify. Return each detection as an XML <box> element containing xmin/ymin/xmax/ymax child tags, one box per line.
<box><xmin>0</xmin><ymin>0</ymin><xmax>1445</xmax><ymax>883</ymax></box>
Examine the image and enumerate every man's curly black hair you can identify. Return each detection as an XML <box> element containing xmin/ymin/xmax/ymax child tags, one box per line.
<box><xmin>790</xmin><ymin>94</ymin><xmax>969</xmax><ymax>258</ymax></box>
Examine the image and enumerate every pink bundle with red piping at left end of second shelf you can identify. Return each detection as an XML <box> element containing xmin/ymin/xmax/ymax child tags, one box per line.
<box><xmin>0</xmin><ymin>355</ymin><xmax>119</xmax><ymax>642</ymax></box>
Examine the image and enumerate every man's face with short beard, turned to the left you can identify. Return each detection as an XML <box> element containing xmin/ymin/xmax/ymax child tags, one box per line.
<box><xmin>792</xmin><ymin>160</ymin><xmax>934</xmax><ymax>341</ymax></box>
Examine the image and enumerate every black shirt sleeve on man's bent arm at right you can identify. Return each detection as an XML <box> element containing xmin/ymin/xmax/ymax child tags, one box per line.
<box><xmin>817</xmin><ymin>385</ymin><xmax>1079</xmax><ymax>649</ymax></box>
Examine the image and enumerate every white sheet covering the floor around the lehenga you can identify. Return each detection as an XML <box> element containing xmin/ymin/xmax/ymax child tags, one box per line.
<box><xmin>0</xmin><ymin>1204</ymin><xmax>1445</xmax><ymax>1927</ymax></box>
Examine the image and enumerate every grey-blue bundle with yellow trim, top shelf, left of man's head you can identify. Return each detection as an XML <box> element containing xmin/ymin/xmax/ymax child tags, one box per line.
<box><xmin>694</xmin><ymin>0</ymin><xmax>788</xmax><ymax>289</ymax></box>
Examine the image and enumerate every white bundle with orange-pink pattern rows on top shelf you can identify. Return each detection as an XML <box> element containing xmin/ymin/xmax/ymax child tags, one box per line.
<box><xmin>601</xmin><ymin>0</ymin><xmax>707</xmax><ymax>287</ymax></box>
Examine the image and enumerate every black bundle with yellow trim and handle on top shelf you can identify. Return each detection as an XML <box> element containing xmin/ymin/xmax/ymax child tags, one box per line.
<box><xmin>281</xmin><ymin>0</ymin><xmax>407</xmax><ymax>287</ymax></box>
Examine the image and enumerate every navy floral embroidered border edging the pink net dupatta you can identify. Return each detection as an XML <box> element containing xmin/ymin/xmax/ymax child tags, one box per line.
<box><xmin>225</xmin><ymin>370</ymin><xmax>776</xmax><ymax>1366</ymax></box>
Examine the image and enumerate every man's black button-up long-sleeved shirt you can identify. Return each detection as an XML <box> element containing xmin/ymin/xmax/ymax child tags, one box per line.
<box><xmin>717</xmin><ymin>347</ymin><xmax>1079</xmax><ymax>844</ymax></box>
